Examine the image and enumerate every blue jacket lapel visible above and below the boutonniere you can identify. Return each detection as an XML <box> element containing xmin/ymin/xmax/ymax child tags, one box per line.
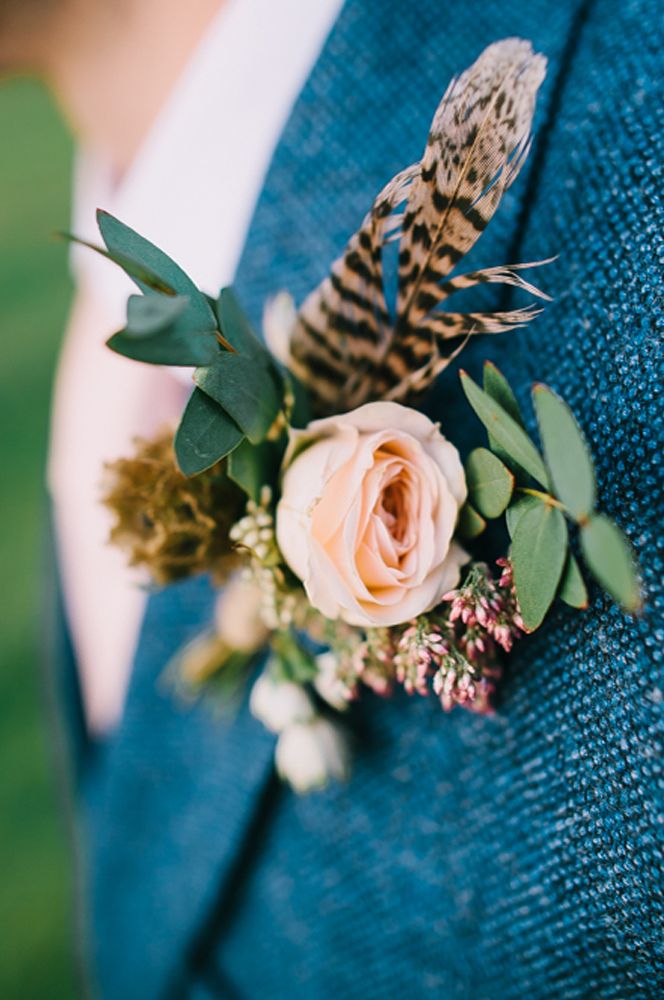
<box><xmin>89</xmin><ymin>0</ymin><xmax>588</xmax><ymax>1000</ymax></box>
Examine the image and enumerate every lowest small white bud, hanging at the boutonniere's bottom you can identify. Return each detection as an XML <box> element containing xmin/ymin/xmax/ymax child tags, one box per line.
<box><xmin>275</xmin><ymin>718</ymin><xmax>349</xmax><ymax>794</ymax></box>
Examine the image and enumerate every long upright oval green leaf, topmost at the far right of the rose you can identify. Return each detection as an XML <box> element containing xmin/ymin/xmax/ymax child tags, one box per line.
<box><xmin>533</xmin><ymin>384</ymin><xmax>595</xmax><ymax>520</ymax></box>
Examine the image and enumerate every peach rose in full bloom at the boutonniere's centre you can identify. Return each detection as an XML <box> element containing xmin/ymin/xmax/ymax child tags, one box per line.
<box><xmin>277</xmin><ymin>402</ymin><xmax>468</xmax><ymax>627</ymax></box>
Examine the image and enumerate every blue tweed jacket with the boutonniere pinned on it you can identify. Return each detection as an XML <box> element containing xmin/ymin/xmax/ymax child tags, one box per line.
<box><xmin>59</xmin><ymin>0</ymin><xmax>664</xmax><ymax>1000</ymax></box>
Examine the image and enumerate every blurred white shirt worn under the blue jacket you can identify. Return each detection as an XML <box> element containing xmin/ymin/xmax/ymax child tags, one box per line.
<box><xmin>49</xmin><ymin>0</ymin><xmax>342</xmax><ymax>735</ymax></box>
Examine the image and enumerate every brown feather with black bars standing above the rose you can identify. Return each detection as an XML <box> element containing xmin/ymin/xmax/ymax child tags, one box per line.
<box><xmin>290</xmin><ymin>38</ymin><xmax>548</xmax><ymax>412</ymax></box>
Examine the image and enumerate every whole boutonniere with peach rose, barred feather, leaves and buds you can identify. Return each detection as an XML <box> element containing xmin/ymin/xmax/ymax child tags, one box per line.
<box><xmin>65</xmin><ymin>39</ymin><xmax>641</xmax><ymax>791</ymax></box>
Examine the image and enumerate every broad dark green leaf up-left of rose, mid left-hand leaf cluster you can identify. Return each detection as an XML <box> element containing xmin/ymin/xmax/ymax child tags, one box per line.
<box><xmin>194</xmin><ymin>351</ymin><xmax>281</xmax><ymax>444</ymax></box>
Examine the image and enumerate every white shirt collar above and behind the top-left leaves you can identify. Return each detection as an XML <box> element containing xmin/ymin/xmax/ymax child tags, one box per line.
<box><xmin>72</xmin><ymin>0</ymin><xmax>342</xmax><ymax>322</ymax></box>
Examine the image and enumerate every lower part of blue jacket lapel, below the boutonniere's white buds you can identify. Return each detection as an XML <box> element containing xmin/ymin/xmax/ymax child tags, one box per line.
<box><xmin>88</xmin><ymin>580</ymin><xmax>273</xmax><ymax>998</ymax></box>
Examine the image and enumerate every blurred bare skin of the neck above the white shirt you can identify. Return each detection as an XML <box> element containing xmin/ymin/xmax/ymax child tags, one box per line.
<box><xmin>21</xmin><ymin>0</ymin><xmax>228</xmax><ymax>180</ymax></box>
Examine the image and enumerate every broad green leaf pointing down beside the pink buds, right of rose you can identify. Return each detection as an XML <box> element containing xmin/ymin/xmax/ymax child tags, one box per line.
<box><xmin>511</xmin><ymin>501</ymin><xmax>567</xmax><ymax>632</ymax></box>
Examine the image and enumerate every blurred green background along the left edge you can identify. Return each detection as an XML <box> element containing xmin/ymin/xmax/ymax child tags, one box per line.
<box><xmin>0</xmin><ymin>80</ymin><xmax>80</xmax><ymax>1000</ymax></box>
